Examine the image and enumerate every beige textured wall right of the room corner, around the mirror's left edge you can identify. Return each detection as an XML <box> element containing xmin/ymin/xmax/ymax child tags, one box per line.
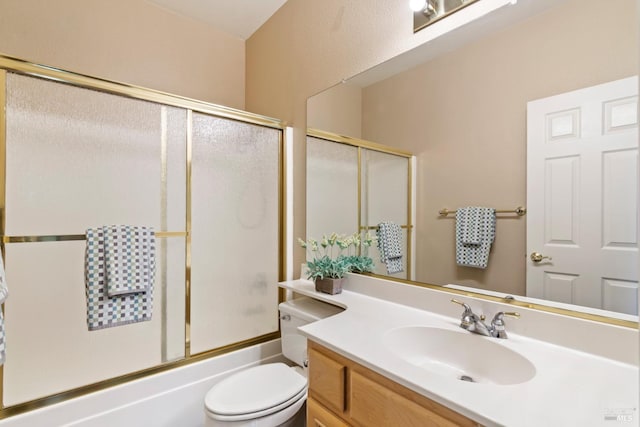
<box><xmin>246</xmin><ymin>0</ymin><xmax>496</xmax><ymax>273</ymax></box>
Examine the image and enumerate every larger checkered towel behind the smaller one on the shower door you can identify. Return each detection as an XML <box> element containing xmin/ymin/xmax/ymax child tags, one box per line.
<box><xmin>85</xmin><ymin>227</ymin><xmax>156</xmax><ymax>331</ymax></box>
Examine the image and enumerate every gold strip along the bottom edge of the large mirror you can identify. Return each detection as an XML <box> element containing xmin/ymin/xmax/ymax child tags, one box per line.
<box><xmin>361</xmin><ymin>273</ymin><xmax>639</xmax><ymax>329</ymax></box>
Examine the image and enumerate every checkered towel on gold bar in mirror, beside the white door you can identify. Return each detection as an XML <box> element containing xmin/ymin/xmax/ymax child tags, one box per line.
<box><xmin>456</xmin><ymin>207</ymin><xmax>496</xmax><ymax>268</ymax></box>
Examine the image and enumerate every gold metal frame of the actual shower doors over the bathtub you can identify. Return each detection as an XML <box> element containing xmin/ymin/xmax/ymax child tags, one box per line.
<box><xmin>0</xmin><ymin>54</ymin><xmax>287</xmax><ymax>419</ymax></box>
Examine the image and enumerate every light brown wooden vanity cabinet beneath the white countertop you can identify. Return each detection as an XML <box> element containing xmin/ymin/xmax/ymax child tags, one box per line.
<box><xmin>307</xmin><ymin>341</ymin><xmax>479</xmax><ymax>427</ymax></box>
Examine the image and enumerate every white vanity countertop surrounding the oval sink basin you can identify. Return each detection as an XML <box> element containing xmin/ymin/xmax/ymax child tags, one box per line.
<box><xmin>280</xmin><ymin>280</ymin><xmax>640</xmax><ymax>427</ymax></box>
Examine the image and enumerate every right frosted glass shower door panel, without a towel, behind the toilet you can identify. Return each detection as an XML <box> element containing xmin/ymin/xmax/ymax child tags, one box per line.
<box><xmin>191</xmin><ymin>113</ymin><xmax>281</xmax><ymax>353</ymax></box>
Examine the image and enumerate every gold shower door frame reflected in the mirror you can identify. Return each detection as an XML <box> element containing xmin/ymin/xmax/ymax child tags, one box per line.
<box><xmin>307</xmin><ymin>128</ymin><xmax>413</xmax><ymax>280</ymax></box>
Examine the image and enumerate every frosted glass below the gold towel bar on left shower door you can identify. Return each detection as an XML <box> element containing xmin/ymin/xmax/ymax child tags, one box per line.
<box><xmin>4</xmin><ymin>241</ymin><xmax>184</xmax><ymax>405</ymax></box>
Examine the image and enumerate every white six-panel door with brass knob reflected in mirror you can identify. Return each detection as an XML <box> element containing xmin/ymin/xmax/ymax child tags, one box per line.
<box><xmin>527</xmin><ymin>77</ymin><xmax>638</xmax><ymax>314</ymax></box>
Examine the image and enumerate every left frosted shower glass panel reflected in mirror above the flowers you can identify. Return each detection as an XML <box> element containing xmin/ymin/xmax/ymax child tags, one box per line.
<box><xmin>306</xmin><ymin>137</ymin><xmax>358</xmax><ymax>239</ymax></box>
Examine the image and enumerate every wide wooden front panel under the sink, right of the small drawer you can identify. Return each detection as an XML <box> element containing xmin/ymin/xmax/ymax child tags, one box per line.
<box><xmin>349</xmin><ymin>372</ymin><xmax>460</xmax><ymax>427</ymax></box>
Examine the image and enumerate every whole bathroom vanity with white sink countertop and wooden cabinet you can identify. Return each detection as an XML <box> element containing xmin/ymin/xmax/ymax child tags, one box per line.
<box><xmin>280</xmin><ymin>275</ymin><xmax>639</xmax><ymax>427</ymax></box>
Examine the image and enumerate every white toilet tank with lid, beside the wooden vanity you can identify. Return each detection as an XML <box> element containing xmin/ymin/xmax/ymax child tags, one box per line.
<box><xmin>279</xmin><ymin>297</ymin><xmax>343</xmax><ymax>366</ymax></box>
